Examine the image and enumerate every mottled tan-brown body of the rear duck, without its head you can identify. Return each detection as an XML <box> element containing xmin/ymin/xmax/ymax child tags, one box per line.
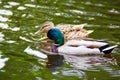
<box><xmin>56</xmin><ymin>24</ymin><xmax>93</xmax><ymax>40</ymax></box>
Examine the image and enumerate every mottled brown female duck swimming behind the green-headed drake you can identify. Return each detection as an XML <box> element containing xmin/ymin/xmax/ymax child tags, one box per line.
<box><xmin>35</xmin><ymin>21</ymin><xmax>93</xmax><ymax>40</ymax></box>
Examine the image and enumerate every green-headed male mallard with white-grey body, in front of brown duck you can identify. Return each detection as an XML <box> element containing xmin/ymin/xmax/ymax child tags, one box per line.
<box><xmin>47</xmin><ymin>28</ymin><xmax>117</xmax><ymax>55</ymax></box>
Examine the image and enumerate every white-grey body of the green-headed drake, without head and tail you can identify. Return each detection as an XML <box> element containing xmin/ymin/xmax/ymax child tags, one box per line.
<box><xmin>58</xmin><ymin>40</ymin><xmax>108</xmax><ymax>55</ymax></box>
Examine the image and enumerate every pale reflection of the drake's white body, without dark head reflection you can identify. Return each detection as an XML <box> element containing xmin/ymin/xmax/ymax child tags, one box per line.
<box><xmin>64</xmin><ymin>55</ymin><xmax>116</xmax><ymax>70</ymax></box>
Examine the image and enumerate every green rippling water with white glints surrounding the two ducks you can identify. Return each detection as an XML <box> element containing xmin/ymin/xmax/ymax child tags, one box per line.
<box><xmin>0</xmin><ymin>0</ymin><xmax>120</xmax><ymax>80</ymax></box>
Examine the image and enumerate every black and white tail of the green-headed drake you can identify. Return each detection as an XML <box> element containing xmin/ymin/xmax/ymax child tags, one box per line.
<box><xmin>99</xmin><ymin>45</ymin><xmax>118</xmax><ymax>54</ymax></box>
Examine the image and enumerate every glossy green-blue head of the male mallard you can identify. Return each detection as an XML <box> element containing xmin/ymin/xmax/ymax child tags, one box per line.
<box><xmin>47</xmin><ymin>28</ymin><xmax>64</xmax><ymax>46</ymax></box>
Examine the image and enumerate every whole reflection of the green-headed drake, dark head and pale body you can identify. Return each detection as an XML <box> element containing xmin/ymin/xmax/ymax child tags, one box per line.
<box><xmin>46</xmin><ymin>54</ymin><xmax>117</xmax><ymax>71</ymax></box>
